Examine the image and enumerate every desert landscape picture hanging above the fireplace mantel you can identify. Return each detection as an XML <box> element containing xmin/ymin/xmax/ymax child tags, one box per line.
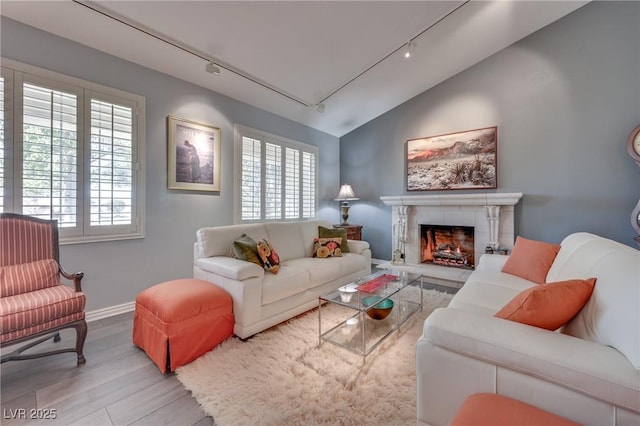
<box><xmin>406</xmin><ymin>126</ymin><xmax>498</xmax><ymax>191</ymax></box>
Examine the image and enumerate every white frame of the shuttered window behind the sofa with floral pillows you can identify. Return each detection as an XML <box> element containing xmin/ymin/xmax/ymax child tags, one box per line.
<box><xmin>233</xmin><ymin>124</ymin><xmax>320</xmax><ymax>224</ymax></box>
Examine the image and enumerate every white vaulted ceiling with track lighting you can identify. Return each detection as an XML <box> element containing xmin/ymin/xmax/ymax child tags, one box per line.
<box><xmin>0</xmin><ymin>0</ymin><xmax>587</xmax><ymax>136</ymax></box>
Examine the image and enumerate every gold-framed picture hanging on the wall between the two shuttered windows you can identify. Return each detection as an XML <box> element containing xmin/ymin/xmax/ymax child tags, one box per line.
<box><xmin>167</xmin><ymin>116</ymin><xmax>222</xmax><ymax>191</ymax></box>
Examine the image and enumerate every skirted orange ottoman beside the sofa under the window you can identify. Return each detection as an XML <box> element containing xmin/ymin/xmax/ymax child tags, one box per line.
<box><xmin>133</xmin><ymin>279</ymin><xmax>234</xmax><ymax>374</ymax></box>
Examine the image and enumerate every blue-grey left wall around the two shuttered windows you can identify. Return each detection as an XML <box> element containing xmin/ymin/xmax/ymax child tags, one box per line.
<box><xmin>0</xmin><ymin>17</ymin><xmax>340</xmax><ymax>311</ymax></box>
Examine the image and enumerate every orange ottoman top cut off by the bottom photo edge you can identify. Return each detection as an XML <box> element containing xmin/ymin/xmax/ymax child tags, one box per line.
<box><xmin>450</xmin><ymin>393</ymin><xmax>580</xmax><ymax>426</ymax></box>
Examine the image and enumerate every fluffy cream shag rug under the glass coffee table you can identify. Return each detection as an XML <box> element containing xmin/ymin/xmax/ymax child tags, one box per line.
<box><xmin>176</xmin><ymin>288</ymin><xmax>453</xmax><ymax>426</ymax></box>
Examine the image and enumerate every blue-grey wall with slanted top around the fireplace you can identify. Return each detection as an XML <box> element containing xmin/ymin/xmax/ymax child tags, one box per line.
<box><xmin>340</xmin><ymin>2</ymin><xmax>640</xmax><ymax>259</ymax></box>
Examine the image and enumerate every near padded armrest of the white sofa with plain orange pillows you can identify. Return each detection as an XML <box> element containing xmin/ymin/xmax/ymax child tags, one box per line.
<box><xmin>418</xmin><ymin>308</ymin><xmax>640</xmax><ymax>411</ymax></box>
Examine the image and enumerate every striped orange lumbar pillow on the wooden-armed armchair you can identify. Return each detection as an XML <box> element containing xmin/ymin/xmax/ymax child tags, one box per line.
<box><xmin>0</xmin><ymin>259</ymin><xmax>60</xmax><ymax>297</ymax></box>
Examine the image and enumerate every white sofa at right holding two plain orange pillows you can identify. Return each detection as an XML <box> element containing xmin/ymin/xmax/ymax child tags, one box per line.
<box><xmin>416</xmin><ymin>233</ymin><xmax>640</xmax><ymax>426</ymax></box>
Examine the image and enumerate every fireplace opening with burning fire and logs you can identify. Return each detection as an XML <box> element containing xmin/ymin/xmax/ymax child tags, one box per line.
<box><xmin>420</xmin><ymin>225</ymin><xmax>475</xmax><ymax>269</ymax></box>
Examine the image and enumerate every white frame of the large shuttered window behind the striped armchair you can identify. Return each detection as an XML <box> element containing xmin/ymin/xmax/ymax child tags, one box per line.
<box><xmin>2</xmin><ymin>58</ymin><xmax>146</xmax><ymax>244</ymax></box>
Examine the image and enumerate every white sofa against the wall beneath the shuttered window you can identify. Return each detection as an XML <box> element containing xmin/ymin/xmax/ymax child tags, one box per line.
<box><xmin>193</xmin><ymin>221</ymin><xmax>371</xmax><ymax>339</ymax></box>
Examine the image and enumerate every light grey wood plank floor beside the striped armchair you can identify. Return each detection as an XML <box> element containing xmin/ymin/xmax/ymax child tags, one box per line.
<box><xmin>0</xmin><ymin>313</ymin><xmax>215</xmax><ymax>426</ymax></box>
